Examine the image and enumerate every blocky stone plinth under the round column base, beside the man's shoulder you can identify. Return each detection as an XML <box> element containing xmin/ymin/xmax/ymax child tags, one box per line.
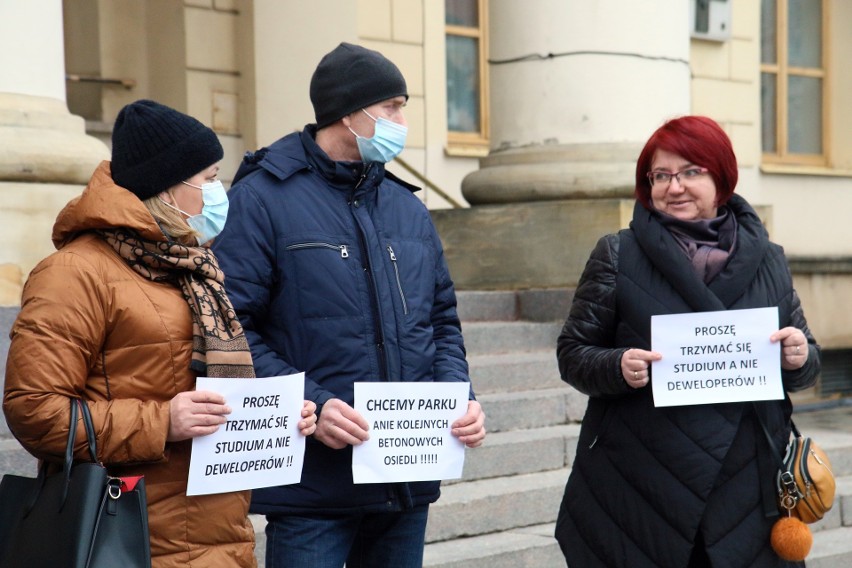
<box><xmin>432</xmin><ymin>198</ymin><xmax>634</xmax><ymax>290</ymax></box>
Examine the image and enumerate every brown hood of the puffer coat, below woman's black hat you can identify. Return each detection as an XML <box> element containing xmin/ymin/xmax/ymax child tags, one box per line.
<box><xmin>52</xmin><ymin>160</ymin><xmax>165</xmax><ymax>249</ymax></box>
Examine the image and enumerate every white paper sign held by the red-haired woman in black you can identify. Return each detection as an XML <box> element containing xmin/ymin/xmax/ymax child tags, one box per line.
<box><xmin>651</xmin><ymin>308</ymin><xmax>784</xmax><ymax>406</ymax></box>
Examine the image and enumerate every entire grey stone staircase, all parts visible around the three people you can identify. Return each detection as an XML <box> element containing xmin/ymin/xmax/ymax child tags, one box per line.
<box><xmin>0</xmin><ymin>296</ymin><xmax>852</xmax><ymax>568</ymax></box>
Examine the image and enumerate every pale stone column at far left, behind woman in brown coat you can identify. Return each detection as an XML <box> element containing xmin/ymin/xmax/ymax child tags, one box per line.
<box><xmin>0</xmin><ymin>0</ymin><xmax>109</xmax><ymax>305</ymax></box>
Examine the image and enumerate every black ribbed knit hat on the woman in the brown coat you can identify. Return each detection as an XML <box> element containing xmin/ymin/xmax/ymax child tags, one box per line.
<box><xmin>111</xmin><ymin>100</ymin><xmax>224</xmax><ymax>200</ymax></box>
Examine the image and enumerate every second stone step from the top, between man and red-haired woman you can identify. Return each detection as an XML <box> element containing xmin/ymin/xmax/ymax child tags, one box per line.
<box><xmin>462</xmin><ymin>321</ymin><xmax>562</xmax><ymax>357</ymax></box>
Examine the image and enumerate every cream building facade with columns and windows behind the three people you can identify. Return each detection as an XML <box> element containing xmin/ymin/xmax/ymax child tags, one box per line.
<box><xmin>0</xmin><ymin>0</ymin><xmax>852</xmax><ymax>396</ymax></box>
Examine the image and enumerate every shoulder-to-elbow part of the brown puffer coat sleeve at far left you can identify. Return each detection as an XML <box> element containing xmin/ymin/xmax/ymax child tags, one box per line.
<box><xmin>3</xmin><ymin>253</ymin><xmax>106</xmax><ymax>461</ymax></box>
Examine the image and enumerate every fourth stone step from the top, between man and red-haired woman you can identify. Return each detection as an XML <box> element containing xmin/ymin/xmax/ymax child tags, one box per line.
<box><xmin>476</xmin><ymin>385</ymin><xmax>587</xmax><ymax>432</ymax></box>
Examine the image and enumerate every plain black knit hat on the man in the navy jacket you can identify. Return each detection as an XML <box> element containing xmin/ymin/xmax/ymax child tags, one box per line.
<box><xmin>311</xmin><ymin>43</ymin><xmax>408</xmax><ymax>128</ymax></box>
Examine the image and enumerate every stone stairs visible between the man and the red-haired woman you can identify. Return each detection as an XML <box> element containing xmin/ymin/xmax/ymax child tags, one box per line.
<box><xmin>424</xmin><ymin>290</ymin><xmax>586</xmax><ymax>568</ymax></box>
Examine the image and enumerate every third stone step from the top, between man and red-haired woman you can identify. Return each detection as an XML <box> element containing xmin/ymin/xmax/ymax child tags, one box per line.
<box><xmin>467</xmin><ymin>349</ymin><xmax>566</xmax><ymax>395</ymax></box>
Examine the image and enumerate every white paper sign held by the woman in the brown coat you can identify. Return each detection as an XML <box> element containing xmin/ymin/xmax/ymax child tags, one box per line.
<box><xmin>186</xmin><ymin>373</ymin><xmax>305</xmax><ymax>495</ymax></box>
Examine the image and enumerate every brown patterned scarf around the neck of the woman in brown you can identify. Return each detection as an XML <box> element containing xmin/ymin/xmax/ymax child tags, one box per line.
<box><xmin>98</xmin><ymin>229</ymin><xmax>254</xmax><ymax>378</ymax></box>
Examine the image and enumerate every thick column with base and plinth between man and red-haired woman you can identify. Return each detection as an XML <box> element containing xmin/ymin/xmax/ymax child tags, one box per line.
<box><xmin>433</xmin><ymin>0</ymin><xmax>690</xmax><ymax>288</ymax></box>
